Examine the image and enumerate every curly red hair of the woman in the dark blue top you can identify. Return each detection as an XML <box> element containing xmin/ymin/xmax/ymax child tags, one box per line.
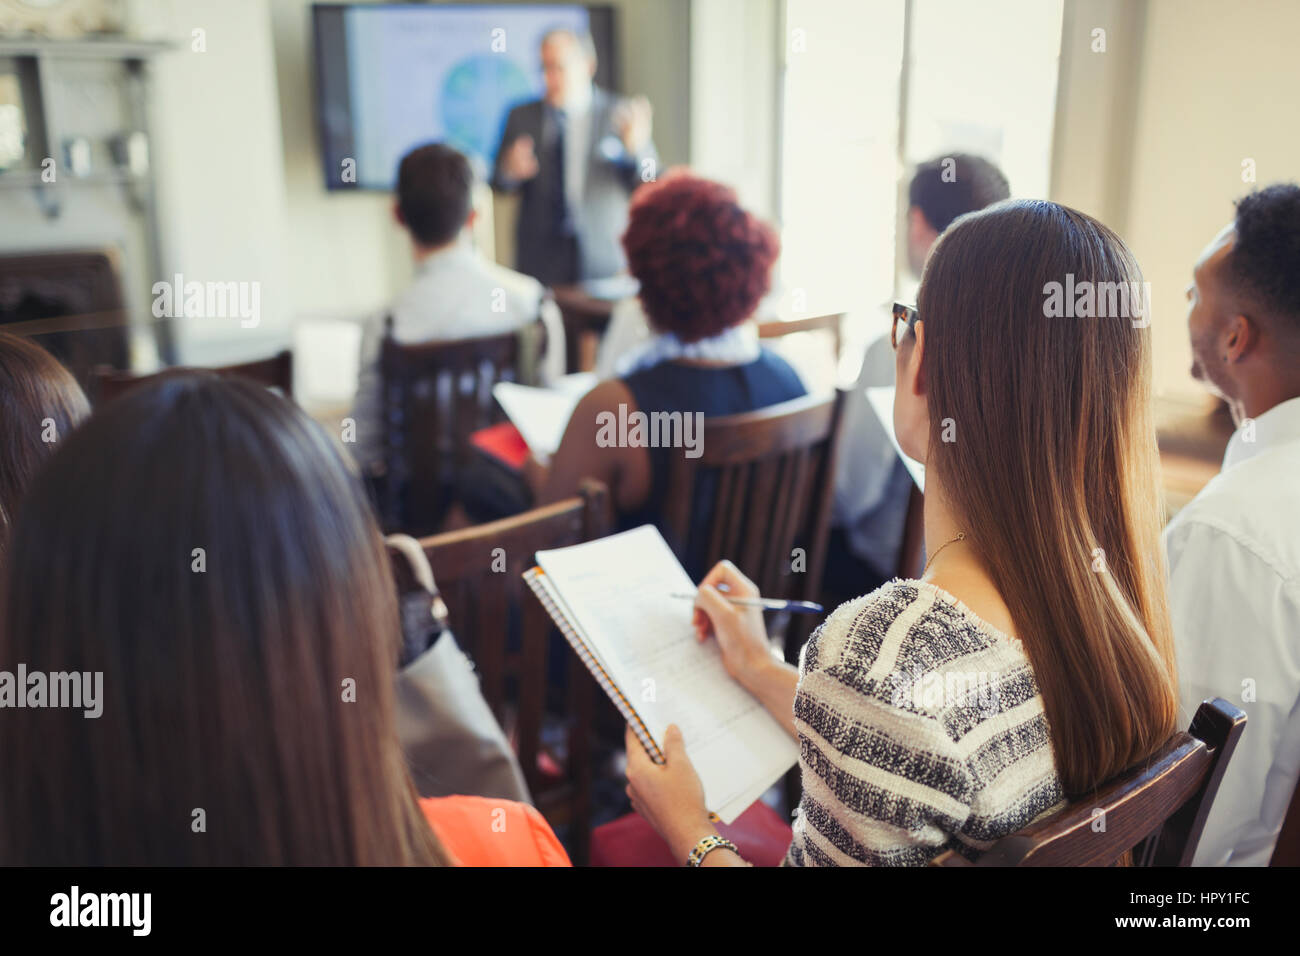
<box><xmin>623</xmin><ymin>169</ymin><xmax>781</xmax><ymax>342</ymax></box>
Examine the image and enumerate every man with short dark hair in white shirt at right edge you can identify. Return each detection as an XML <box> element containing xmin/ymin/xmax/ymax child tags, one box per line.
<box><xmin>1165</xmin><ymin>185</ymin><xmax>1300</xmax><ymax>866</ymax></box>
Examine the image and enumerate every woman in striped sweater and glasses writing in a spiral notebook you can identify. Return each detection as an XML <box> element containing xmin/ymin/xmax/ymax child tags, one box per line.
<box><xmin>628</xmin><ymin>202</ymin><xmax>1178</xmax><ymax>866</ymax></box>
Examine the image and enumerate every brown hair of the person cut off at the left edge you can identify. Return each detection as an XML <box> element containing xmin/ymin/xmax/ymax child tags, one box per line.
<box><xmin>0</xmin><ymin>332</ymin><xmax>90</xmax><ymax>562</ymax></box>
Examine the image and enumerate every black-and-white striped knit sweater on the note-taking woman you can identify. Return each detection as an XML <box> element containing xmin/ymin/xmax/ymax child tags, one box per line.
<box><xmin>785</xmin><ymin>580</ymin><xmax>1065</xmax><ymax>866</ymax></box>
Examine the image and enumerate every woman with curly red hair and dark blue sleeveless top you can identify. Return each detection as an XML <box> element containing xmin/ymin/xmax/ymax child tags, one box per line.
<box><xmin>540</xmin><ymin>169</ymin><xmax>805</xmax><ymax>578</ymax></box>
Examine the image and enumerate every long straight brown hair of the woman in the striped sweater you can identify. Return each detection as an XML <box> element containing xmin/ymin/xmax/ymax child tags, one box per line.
<box><xmin>918</xmin><ymin>202</ymin><xmax>1178</xmax><ymax>796</ymax></box>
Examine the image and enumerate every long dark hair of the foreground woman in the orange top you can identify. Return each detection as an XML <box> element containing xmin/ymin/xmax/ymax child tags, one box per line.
<box><xmin>0</xmin><ymin>373</ymin><xmax>446</xmax><ymax>866</ymax></box>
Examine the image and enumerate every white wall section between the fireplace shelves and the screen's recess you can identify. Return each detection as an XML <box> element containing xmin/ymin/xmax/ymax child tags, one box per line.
<box><xmin>142</xmin><ymin>0</ymin><xmax>294</xmax><ymax>364</ymax></box>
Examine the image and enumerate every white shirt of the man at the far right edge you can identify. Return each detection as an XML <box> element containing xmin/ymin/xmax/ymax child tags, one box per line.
<box><xmin>1165</xmin><ymin>398</ymin><xmax>1300</xmax><ymax>866</ymax></box>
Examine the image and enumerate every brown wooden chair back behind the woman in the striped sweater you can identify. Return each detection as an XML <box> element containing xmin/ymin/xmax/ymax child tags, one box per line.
<box><xmin>932</xmin><ymin>697</ymin><xmax>1245</xmax><ymax>866</ymax></box>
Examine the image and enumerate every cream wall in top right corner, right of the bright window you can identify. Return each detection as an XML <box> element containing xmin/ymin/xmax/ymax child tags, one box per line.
<box><xmin>1052</xmin><ymin>0</ymin><xmax>1300</xmax><ymax>402</ymax></box>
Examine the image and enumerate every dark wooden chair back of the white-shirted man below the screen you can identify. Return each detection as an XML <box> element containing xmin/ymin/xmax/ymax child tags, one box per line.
<box><xmin>372</xmin><ymin>316</ymin><xmax>545</xmax><ymax>535</ymax></box>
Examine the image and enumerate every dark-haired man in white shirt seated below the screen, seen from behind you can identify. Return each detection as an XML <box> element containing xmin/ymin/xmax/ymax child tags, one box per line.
<box><xmin>352</xmin><ymin>143</ymin><xmax>564</xmax><ymax>468</ymax></box>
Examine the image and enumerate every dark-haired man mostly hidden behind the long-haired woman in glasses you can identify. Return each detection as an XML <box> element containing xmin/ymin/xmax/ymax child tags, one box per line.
<box><xmin>824</xmin><ymin>153</ymin><xmax>1011</xmax><ymax>601</ymax></box>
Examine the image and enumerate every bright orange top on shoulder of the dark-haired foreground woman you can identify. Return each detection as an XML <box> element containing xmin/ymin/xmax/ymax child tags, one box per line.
<box><xmin>420</xmin><ymin>795</ymin><xmax>572</xmax><ymax>866</ymax></box>
